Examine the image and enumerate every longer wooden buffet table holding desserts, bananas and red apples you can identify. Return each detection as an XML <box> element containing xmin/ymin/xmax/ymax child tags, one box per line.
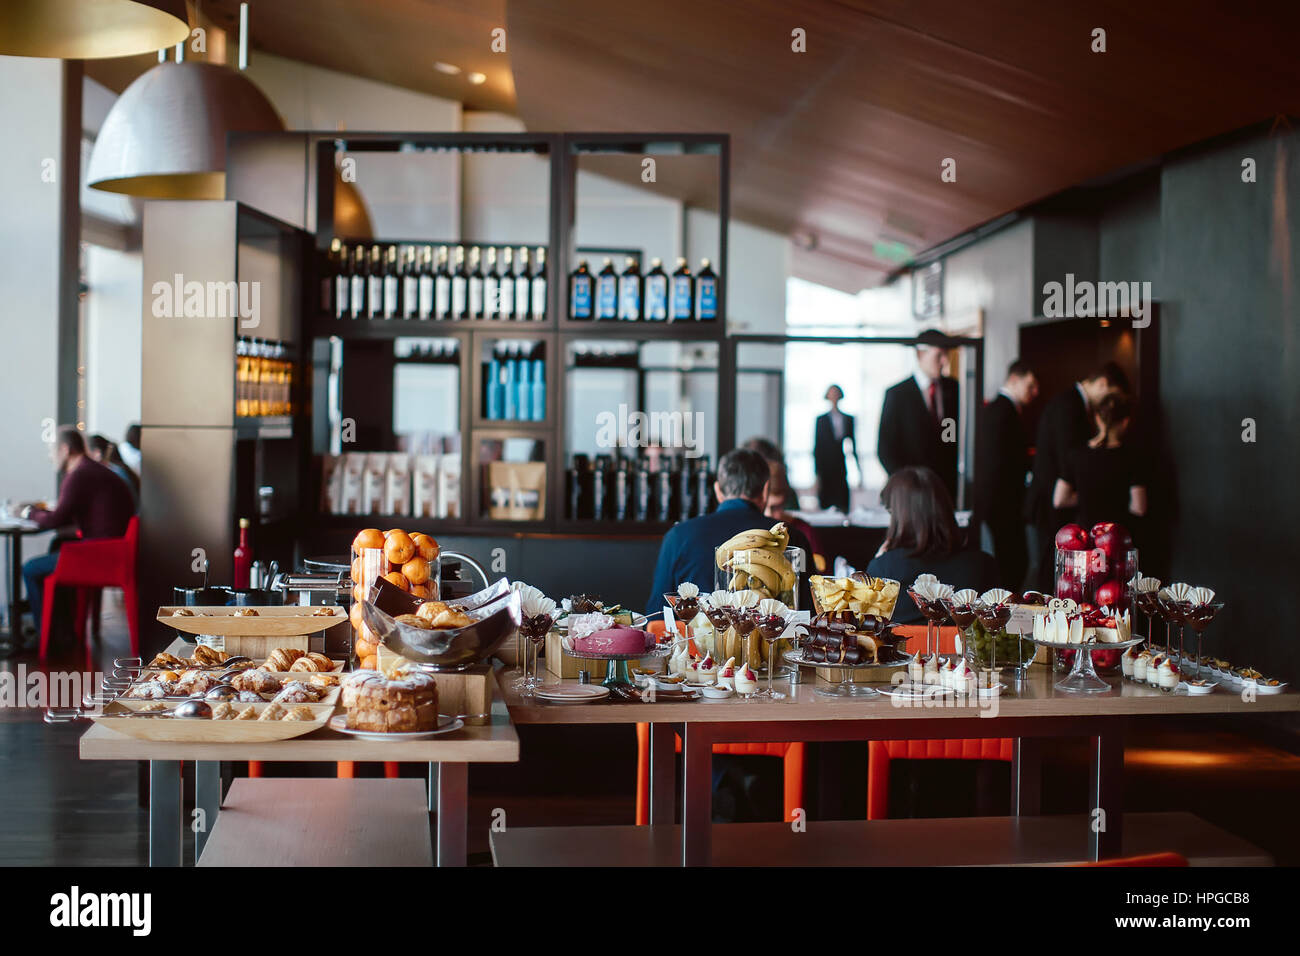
<box><xmin>493</xmin><ymin>666</ymin><xmax>1300</xmax><ymax>866</ymax></box>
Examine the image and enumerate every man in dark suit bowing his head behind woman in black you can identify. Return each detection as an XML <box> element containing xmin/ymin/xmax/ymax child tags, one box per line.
<box><xmin>1023</xmin><ymin>362</ymin><xmax>1128</xmax><ymax>594</ymax></box>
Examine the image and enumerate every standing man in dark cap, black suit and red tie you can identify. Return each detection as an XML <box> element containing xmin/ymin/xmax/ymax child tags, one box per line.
<box><xmin>876</xmin><ymin>329</ymin><xmax>959</xmax><ymax>501</ymax></box>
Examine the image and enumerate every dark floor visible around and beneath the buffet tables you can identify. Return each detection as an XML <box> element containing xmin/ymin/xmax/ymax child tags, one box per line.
<box><xmin>0</xmin><ymin>594</ymin><xmax>1300</xmax><ymax>865</ymax></box>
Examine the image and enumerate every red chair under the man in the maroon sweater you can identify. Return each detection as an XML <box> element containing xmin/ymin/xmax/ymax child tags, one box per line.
<box><xmin>40</xmin><ymin>518</ymin><xmax>140</xmax><ymax>661</ymax></box>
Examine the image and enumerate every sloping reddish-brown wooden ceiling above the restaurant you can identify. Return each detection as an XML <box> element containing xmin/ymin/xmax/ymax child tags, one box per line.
<box><xmin>89</xmin><ymin>0</ymin><xmax>1300</xmax><ymax>291</ymax></box>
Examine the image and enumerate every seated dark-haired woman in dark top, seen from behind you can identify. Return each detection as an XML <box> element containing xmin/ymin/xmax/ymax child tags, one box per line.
<box><xmin>867</xmin><ymin>467</ymin><xmax>998</xmax><ymax>624</ymax></box>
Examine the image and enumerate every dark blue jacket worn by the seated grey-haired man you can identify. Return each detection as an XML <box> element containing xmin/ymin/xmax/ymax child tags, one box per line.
<box><xmin>646</xmin><ymin>498</ymin><xmax>813</xmax><ymax>614</ymax></box>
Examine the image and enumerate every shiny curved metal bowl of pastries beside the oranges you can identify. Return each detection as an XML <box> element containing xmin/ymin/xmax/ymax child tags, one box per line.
<box><xmin>361</xmin><ymin>578</ymin><xmax>521</xmax><ymax>671</ymax></box>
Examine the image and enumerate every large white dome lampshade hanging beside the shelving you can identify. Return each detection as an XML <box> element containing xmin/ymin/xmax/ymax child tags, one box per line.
<box><xmin>87</xmin><ymin>62</ymin><xmax>285</xmax><ymax>199</ymax></box>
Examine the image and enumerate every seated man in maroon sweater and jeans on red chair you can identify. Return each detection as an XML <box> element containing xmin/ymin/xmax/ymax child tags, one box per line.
<box><xmin>22</xmin><ymin>425</ymin><xmax>135</xmax><ymax>642</ymax></box>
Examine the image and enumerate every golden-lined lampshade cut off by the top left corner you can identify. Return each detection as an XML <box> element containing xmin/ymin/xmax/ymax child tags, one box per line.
<box><xmin>0</xmin><ymin>0</ymin><xmax>190</xmax><ymax>60</ymax></box>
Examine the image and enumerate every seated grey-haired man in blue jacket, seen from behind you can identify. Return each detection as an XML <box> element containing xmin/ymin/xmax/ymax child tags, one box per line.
<box><xmin>646</xmin><ymin>449</ymin><xmax>811</xmax><ymax>614</ymax></box>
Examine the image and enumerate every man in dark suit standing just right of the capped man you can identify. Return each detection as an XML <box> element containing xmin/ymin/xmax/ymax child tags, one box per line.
<box><xmin>972</xmin><ymin>359</ymin><xmax>1039</xmax><ymax>589</ymax></box>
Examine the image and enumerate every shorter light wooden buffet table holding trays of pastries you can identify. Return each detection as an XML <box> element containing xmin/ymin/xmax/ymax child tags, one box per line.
<box><xmin>81</xmin><ymin>641</ymin><xmax>519</xmax><ymax>866</ymax></box>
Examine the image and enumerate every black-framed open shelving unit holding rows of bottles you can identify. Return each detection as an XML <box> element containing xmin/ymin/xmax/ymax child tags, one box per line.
<box><xmin>303</xmin><ymin>133</ymin><xmax>736</xmax><ymax>536</ymax></box>
